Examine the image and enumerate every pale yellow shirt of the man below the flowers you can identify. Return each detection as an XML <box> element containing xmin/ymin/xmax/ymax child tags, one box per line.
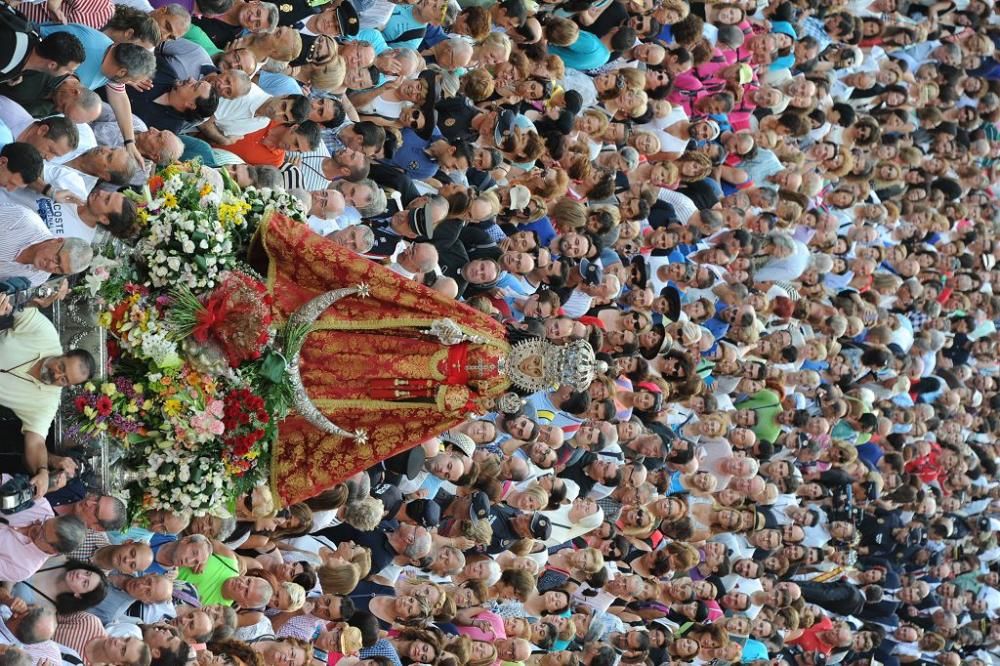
<box><xmin>0</xmin><ymin>308</ymin><xmax>62</xmax><ymax>437</ymax></box>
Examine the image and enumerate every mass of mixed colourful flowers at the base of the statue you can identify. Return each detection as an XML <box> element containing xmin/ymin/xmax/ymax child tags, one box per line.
<box><xmin>71</xmin><ymin>161</ymin><xmax>307</xmax><ymax>522</ymax></box>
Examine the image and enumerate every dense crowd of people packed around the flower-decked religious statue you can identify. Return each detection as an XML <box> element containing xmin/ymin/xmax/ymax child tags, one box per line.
<box><xmin>0</xmin><ymin>0</ymin><xmax>1000</xmax><ymax>666</ymax></box>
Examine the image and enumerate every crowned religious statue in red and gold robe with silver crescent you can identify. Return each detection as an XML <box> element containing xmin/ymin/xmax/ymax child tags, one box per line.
<box><xmin>251</xmin><ymin>214</ymin><xmax>596</xmax><ymax>505</ymax></box>
